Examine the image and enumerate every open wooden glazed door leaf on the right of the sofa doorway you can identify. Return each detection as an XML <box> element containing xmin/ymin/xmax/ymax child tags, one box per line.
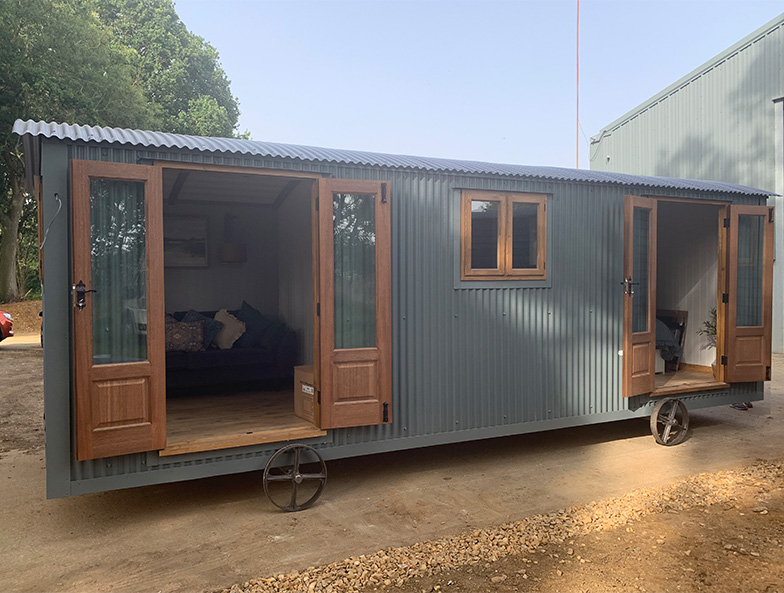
<box><xmin>318</xmin><ymin>179</ymin><xmax>392</xmax><ymax>428</ymax></box>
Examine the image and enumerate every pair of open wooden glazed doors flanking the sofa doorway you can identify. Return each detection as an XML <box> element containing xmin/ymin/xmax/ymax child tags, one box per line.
<box><xmin>71</xmin><ymin>160</ymin><xmax>392</xmax><ymax>460</ymax></box>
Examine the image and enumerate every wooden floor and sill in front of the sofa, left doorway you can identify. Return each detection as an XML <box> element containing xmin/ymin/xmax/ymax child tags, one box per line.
<box><xmin>159</xmin><ymin>391</ymin><xmax>327</xmax><ymax>456</ymax></box>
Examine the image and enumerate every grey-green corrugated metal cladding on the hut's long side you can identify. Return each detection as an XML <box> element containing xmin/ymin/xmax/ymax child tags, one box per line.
<box><xmin>59</xmin><ymin>143</ymin><xmax>764</xmax><ymax>493</ymax></box>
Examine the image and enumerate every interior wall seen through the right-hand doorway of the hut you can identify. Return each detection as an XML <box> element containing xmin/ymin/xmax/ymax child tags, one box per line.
<box><xmin>656</xmin><ymin>202</ymin><xmax>719</xmax><ymax>366</ymax></box>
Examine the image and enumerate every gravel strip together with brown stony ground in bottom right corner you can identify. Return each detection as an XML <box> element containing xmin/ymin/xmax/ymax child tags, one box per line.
<box><xmin>222</xmin><ymin>461</ymin><xmax>784</xmax><ymax>593</ymax></box>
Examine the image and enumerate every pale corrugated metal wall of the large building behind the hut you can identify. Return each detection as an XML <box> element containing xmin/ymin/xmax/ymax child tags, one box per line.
<box><xmin>590</xmin><ymin>15</ymin><xmax>784</xmax><ymax>192</ymax></box>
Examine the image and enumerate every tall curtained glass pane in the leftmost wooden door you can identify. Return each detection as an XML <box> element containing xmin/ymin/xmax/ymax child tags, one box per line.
<box><xmin>87</xmin><ymin>179</ymin><xmax>147</xmax><ymax>364</ymax></box>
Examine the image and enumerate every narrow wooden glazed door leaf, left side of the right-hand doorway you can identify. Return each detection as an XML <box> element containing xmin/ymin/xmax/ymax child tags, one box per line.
<box><xmin>623</xmin><ymin>196</ymin><xmax>656</xmax><ymax>397</ymax></box>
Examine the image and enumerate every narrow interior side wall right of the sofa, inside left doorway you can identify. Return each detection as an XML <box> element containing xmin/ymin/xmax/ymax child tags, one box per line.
<box><xmin>277</xmin><ymin>181</ymin><xmax>313</xmax><ymax>364</ymax></box>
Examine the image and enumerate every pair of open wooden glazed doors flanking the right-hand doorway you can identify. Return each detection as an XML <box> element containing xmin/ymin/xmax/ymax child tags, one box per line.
<box><xmin>622</xmin><ymin>196</ymin><xmax>773</xmax><ymax>397</ymax></box>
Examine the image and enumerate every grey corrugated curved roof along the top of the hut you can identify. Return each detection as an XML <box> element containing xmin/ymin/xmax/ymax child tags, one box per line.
<box><xmin>13</xmin><ymin>120</ymin><xmax>773</xmax><ymax>196</ymax></box>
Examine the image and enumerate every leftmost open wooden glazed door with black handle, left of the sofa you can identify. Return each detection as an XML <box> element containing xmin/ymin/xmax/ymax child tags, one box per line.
<box><xmin>71</xmin><ymin>160</ymin><xmax>166</xmax><ymax>461</ymax></box>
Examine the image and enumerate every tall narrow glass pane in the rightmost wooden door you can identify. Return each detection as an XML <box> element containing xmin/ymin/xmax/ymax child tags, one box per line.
<box><xmin>737</xmin><ymin>215</ymin><xmax>765</xmax><ymax>327</ymax></box>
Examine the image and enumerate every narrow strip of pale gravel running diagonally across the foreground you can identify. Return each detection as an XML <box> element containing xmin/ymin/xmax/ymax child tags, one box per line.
<box><xmin>221</xmin><ymin>461</ymin><xmax>784</xmax><ymax>593</ymax></box>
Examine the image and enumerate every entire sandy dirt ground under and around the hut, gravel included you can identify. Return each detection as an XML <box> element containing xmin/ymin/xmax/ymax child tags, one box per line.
<box><xmin>0</xmin><ymin>300</ymin><xmax>784</xmax><ymax>593</ymax></box>
